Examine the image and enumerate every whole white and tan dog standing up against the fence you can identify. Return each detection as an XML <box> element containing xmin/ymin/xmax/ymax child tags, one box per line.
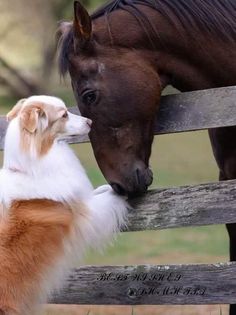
<box><xmin>0</xmin><ymin>96</ymin><xmax>127</xmax><ymax>315</ymax></box>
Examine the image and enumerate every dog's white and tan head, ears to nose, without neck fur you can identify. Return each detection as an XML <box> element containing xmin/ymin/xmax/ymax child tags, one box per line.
<box><xmin>7</xmin><ymin>95</ymin><xmax>92</xmax><ymax>138</ymax></box>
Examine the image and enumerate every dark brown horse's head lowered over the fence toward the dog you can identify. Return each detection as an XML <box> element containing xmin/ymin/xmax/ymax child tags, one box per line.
<box><xmin>60</xmin><ymin>1</ymin><xmax>161</xmax><ymax>195</ymax></box>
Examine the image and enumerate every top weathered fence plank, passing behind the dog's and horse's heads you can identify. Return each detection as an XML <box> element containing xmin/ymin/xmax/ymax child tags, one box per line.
<box><xmin>0</xmin><ymin>86</ymin><xmax>236</xmax><ymax>149</ymax></box>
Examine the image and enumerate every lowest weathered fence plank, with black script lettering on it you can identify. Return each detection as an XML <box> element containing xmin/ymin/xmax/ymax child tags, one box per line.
<box><xmin>50</xmin><ymin>262</ymin><xmax>236</xmax><ymax>305</ymax></box>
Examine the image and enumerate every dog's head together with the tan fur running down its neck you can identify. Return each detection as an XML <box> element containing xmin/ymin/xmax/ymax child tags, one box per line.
<box><xmin>7</xmin><ymin>95</ymin><xmax>92</xmax><ymax>154</ymax></box>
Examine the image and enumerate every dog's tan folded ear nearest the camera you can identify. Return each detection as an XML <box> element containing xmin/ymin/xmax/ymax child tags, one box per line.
<box><xmin>20</xmin><ymin>106</ymin><xmax>41</xmax><ymax>133</ymax></box>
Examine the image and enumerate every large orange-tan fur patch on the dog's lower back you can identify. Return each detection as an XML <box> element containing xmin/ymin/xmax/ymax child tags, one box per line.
<box><xmin>0</xmin><ymin>200</ymin><xmax>73</xmax><ymax>315</ymax></box>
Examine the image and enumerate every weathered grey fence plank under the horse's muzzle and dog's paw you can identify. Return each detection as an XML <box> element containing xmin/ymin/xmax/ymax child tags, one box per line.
<box><xmin>127</xmin><ymin>180</ymin><xmax>236</xmax><ymax>231</ymax></box>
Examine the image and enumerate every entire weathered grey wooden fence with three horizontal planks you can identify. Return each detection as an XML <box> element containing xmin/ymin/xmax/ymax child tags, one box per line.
<box><xmin>0</xmin><ymin>87</ymin><xmax>236</xmax><ymax>305</ymax></box>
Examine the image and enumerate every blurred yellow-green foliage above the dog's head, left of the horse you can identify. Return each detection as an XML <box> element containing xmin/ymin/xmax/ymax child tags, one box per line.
<box><xmin>0</xmin><ymin>0</ymin><xmax>97</xmax><ymax>98</ymax></box>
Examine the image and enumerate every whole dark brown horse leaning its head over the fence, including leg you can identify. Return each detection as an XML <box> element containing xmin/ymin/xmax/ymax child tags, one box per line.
<box><xmin>57</xmin><ymin>0</ymin><xmax>236</xmax><ymax>315</ymax></box>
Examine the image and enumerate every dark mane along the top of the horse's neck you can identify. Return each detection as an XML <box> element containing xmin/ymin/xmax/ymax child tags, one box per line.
<box><xmin>91</xmin><ymin>0</ymin><xmax>236</xmax><ymax>41</ymax></box>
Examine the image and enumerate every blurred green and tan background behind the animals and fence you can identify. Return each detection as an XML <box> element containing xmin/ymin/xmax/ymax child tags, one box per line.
<box><xmin>0</xmin><ymin>0</ymin><xmax>228</xmax><ymax>315</ymax></box>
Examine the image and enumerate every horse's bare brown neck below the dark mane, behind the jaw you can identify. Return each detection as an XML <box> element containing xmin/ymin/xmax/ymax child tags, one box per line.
<box><xmin>153</xmin><ymin>29</ymin><xmax>236</xmax><ymax>91</ymax></box>
